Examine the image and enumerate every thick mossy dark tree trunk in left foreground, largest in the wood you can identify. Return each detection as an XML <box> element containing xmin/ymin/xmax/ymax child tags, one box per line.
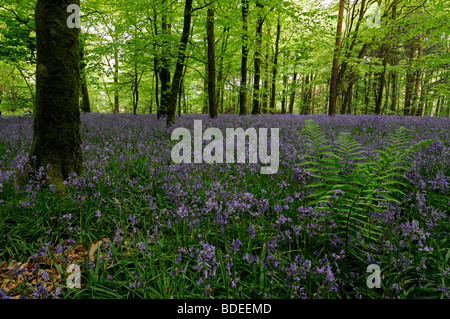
<box><xmin>30</xmin><ymin>0</ymin><xmax>82</xmax><ymax>188</ymax></box>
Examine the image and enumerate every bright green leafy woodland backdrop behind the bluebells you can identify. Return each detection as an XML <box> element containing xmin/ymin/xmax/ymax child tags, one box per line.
<box><xmin>0</xmin><ymin>0</ymin><xmax>450</xmax><ymax>117</ymax></box>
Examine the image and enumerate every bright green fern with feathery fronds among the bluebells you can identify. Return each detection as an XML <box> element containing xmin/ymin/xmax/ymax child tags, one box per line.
<box><xmin>301</xmin><ymin>120</ymin><xmax>432</xmax><ymax>258</ymax></box>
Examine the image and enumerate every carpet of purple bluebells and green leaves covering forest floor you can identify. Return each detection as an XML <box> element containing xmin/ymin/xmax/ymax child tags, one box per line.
<box><xmin>0</xmin><ymin>114</ymin><xmax>450</xmax><ymax>299</ymax></box>
